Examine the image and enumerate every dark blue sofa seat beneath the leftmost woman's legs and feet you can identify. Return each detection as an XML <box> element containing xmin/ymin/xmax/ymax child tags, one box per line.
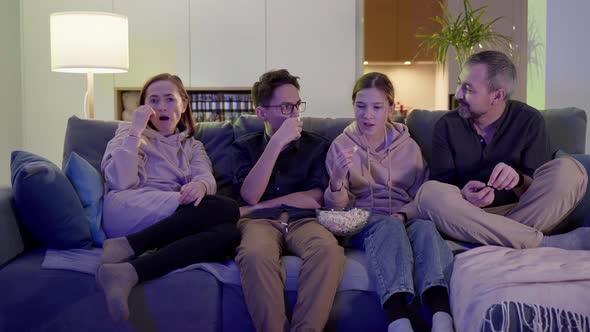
<box><xmin>0</xmin><ymin>248</ymin><xmax>221</xmax><ymax>332</ymax></box>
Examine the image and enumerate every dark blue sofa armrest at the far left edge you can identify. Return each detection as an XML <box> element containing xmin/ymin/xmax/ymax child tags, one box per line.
<box><xmin>0</xmin><ymin>187</ymin><xmax>25</xmax><ymax>266</ymax></box>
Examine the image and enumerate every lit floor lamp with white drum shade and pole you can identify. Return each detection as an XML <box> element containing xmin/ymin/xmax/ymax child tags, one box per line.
<box><xmin>49</xmin><ymin>12</ymin><xmax>129</xmax><ymax>119</ymax></box>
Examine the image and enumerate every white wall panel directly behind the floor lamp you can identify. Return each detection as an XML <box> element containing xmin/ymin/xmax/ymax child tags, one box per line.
<box><xmin>20</xmin><ymin>0</ymin><xmax>114</xmax><ymax>166</ymax></box>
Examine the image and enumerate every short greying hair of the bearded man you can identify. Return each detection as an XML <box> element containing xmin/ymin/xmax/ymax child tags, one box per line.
<box><xmin>465</xmin><ymin>51</ymin><xmax>516</xmax><ymax>99</ymax></box>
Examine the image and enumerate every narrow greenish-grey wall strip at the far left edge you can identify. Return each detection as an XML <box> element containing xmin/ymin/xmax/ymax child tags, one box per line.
<box><xmin>0</xmin><ymin>1</ymin><xmax>22</xmax><ymax>186</ymax></box>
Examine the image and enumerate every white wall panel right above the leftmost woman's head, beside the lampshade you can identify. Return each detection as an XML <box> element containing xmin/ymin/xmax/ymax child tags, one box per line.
<box><xmin>114</xmin><ymin>0</ymin><xmax>190</xmax><ymax>87</ymax></box>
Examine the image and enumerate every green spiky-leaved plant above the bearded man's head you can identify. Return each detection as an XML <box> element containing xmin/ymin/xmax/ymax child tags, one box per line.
<box><xmin>416</xmin><ymin>0</ymin><xmax>512</xmax><ymax>67</ymax></box>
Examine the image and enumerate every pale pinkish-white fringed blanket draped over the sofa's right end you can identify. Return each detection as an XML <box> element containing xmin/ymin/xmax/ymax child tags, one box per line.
<box><xmin>450</xmin><ymin>246</ymin><xmax>590</xmax><ymax>332</ymax></box>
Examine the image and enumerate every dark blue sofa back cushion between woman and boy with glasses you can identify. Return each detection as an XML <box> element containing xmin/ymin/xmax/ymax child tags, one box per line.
<box><xmin>195</xmin><ymin>121</ymin><xmax>234</xmax><ymax>197</ymax></box>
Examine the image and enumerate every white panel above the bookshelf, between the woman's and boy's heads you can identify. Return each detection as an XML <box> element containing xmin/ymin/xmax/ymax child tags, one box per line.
<box><xmin>190</xmin><ymin>0</ymin><xmax>266</xmax><ymax>87</ymax></box>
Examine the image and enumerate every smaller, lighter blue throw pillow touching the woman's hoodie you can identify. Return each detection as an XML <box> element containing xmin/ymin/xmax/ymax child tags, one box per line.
<box><xmin>64</xmin><ymin>152</ymin><xmax>106</xmax><ymax>248</ymax></box>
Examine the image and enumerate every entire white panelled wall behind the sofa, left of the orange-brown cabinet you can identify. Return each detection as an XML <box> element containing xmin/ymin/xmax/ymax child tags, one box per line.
<box><xmin>18</xmin><ymin>0</ymin><xmax>361</xmax><ymax>164</ymax></box>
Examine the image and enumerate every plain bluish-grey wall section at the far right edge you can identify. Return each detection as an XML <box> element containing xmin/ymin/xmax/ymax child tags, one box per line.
<box><xmin>545</xmin><ymin>0</ymin><xmax>590</xmax><ymax>153</ymax></box>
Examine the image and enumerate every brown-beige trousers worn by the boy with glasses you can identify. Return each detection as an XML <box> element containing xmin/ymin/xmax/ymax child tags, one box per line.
<box><xmin>236</xmin><ymin>213</ymin><xmax>344</xmax><ymax>332</ymax></box>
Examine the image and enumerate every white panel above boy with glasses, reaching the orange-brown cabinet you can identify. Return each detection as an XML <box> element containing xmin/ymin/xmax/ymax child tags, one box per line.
<box><xmin>266</xmin><ymin>0</ymin><xmax>360</xmax><ymax>117</ymax></box>
